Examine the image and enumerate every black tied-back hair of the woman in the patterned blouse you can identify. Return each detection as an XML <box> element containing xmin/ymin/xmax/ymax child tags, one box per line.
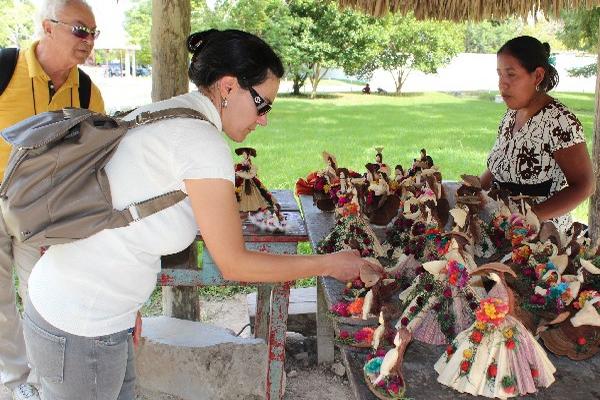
<box><xmin>497</xmin><ymin>36</ymin><xmax>558</xmax><ymax>92</ymax></box>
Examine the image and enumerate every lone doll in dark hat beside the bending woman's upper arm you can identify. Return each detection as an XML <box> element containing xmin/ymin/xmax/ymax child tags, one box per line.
<box><xmin>235</xmin><ymin>147</ymin><xmax>275</xmax><ymax>212</ymax></box>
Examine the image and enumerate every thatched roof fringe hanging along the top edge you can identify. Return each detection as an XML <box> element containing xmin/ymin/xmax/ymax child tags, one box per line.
<box><xmin>338</xmin><ymin>0</ymin><xmax>600</xmax><ymax>21</ymax></box>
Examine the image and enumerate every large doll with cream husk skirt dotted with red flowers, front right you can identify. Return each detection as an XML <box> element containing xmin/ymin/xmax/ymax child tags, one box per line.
<box><xmin>434</xmin><ymin>263</ymin><xmax>556</xmax><ymax>399</ymax></box>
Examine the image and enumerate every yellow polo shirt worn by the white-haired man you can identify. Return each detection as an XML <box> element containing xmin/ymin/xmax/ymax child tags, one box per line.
<box><xmin>0</xmin><ymin>42</ymin><xmax>104</xmax><ymax>180</ymax></box>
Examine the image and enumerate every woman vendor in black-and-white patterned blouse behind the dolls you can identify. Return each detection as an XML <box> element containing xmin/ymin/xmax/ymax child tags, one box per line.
<box><xmin>481</xmin><ymin>36</ymin><xmax>595</xmax><ymax>231</ymax></box>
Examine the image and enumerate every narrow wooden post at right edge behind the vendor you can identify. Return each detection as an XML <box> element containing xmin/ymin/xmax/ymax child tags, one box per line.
<box><xmin>589</xmin><ymin>19</ymin><xmax>600</xmax><ymax>243</ymax></box>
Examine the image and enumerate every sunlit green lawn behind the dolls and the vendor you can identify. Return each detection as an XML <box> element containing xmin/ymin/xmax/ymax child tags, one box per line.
<box><xmin>232</xmin><ymin>92</ymin><xmax>594</xmax><ymax>220</ymax></box>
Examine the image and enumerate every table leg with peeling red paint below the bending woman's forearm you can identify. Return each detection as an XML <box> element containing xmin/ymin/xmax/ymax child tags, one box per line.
<box><xmin>266</xmin><ymin>282</ymin><xmax>292</xmax><ymax>400</ymax></box>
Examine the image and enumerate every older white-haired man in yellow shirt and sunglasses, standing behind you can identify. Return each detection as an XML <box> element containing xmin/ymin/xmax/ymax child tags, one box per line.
<box><xmin>0</xmin><ymin>0</ymin><xmax>104</xmax><ymax>400</ymax></box>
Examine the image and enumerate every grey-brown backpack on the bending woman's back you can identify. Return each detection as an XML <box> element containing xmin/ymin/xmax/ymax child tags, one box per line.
<box><xmin>0</xmin><ymin>108</ymin><xmax>212</xmax><ymax>246</ymax></box>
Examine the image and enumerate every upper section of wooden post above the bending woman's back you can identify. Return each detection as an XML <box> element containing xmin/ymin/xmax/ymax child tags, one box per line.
<box><xmin>151</xmin><ymin>0</ymin><xmax>191</xmax><ymax>101</ymax></box>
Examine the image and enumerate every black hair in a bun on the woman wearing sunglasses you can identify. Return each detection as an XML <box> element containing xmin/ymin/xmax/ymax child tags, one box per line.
<box><xmin>187</xmin><ymin>29</ymin><xmax>284</xmax><ymax>89</ymax></box>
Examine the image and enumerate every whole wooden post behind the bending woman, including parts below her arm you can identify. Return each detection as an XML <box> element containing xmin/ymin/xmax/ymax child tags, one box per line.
<box><xmin>151</xmin><ymin>0</ymin><xmax>200</xmax><ymax>321</ymax></box>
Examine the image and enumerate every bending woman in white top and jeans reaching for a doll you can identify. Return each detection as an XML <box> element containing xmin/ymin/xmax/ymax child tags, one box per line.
<box><xmin>24</xmin><ymin>30</ymin><xmax>377</xmax><ymax>400</ymax></box>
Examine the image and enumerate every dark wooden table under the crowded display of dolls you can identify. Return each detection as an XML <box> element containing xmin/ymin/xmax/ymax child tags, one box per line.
<box><xmin>300</xmin><ymin>196</ymin><xmax>600</xmax><ymax>400</ymax></box>
